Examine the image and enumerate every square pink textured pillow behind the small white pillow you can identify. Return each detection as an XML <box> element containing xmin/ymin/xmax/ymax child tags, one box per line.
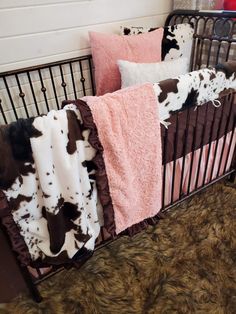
<box><xmin>89</xmin><ymin>28</ymin><xmax>163</xmax><ymax>96</ymax></box>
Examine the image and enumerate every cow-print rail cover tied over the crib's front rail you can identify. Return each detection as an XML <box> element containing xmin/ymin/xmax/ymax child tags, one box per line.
<box><xmin>153</xmin><ymin>67</ymin><xmax>236</xmax><ymax>121</ymax></box>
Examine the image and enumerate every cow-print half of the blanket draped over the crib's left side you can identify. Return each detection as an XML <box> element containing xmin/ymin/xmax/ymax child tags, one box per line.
<box><xmin>0</xmin><ymin>105</ymin><xmax>102</xmax><ymax>263</ymax></box>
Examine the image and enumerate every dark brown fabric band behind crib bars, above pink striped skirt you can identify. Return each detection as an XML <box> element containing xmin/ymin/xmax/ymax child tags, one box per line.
<box><xmin>161</xmin><ymin>93</ymin><xmax>236</xmax><ymax>164</ymax></box>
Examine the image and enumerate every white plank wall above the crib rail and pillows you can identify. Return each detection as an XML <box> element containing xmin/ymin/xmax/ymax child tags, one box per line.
<box><xmin>0</xmin><ymin>0</ymin><xmax>172</xmax><ymax>72</ymax></box>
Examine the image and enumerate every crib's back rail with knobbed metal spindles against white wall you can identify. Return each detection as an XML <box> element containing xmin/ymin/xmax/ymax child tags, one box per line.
<box><xmin>0</xmin><ymin>55</ymin><xmax>95</xmax><ymax>125</ymax></box>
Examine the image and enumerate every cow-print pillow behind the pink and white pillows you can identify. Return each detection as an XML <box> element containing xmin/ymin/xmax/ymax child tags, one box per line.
<box><xmin>120</xmin><ymin>23</ymin><xmax>194</xmax><ymax>63</ymax></box>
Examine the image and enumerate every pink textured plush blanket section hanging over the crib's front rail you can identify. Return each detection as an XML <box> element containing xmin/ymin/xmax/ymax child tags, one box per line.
<box><xmin>83</xmin><ymin>84</ymin><xmax>162</xmax><ymax>234</ymax></box>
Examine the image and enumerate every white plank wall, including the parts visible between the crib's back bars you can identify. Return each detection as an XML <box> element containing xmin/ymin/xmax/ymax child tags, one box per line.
<box><xmin>0</xmin><ymin>0</ymin><xmax>172</xmax><ymax>124</ymax></box>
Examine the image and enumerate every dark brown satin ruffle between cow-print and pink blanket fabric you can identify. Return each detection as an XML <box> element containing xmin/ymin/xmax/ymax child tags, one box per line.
<box><xmin>71</xmin><ymin>99</ymin><xmax>116</xmax><ymax>238</ymax></box>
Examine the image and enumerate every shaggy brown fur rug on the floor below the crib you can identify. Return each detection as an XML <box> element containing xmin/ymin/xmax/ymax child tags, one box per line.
<box><xmin>1</xmin><ymin>183</ymin><xmax>236</xmax><ymax>314</ymax></box>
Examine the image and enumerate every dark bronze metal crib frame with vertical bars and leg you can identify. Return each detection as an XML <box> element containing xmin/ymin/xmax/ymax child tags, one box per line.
<box><xmin>0</xmin><ymin>10</ymin><xmax>236</xmax><ymax>302</ymax></box>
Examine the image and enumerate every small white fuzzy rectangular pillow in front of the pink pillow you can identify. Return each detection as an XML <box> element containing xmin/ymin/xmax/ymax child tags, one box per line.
<box><xmin>117</xmin><ymin>58</ymin><xmax>188</xmax><ymax>88</ymax></box>
